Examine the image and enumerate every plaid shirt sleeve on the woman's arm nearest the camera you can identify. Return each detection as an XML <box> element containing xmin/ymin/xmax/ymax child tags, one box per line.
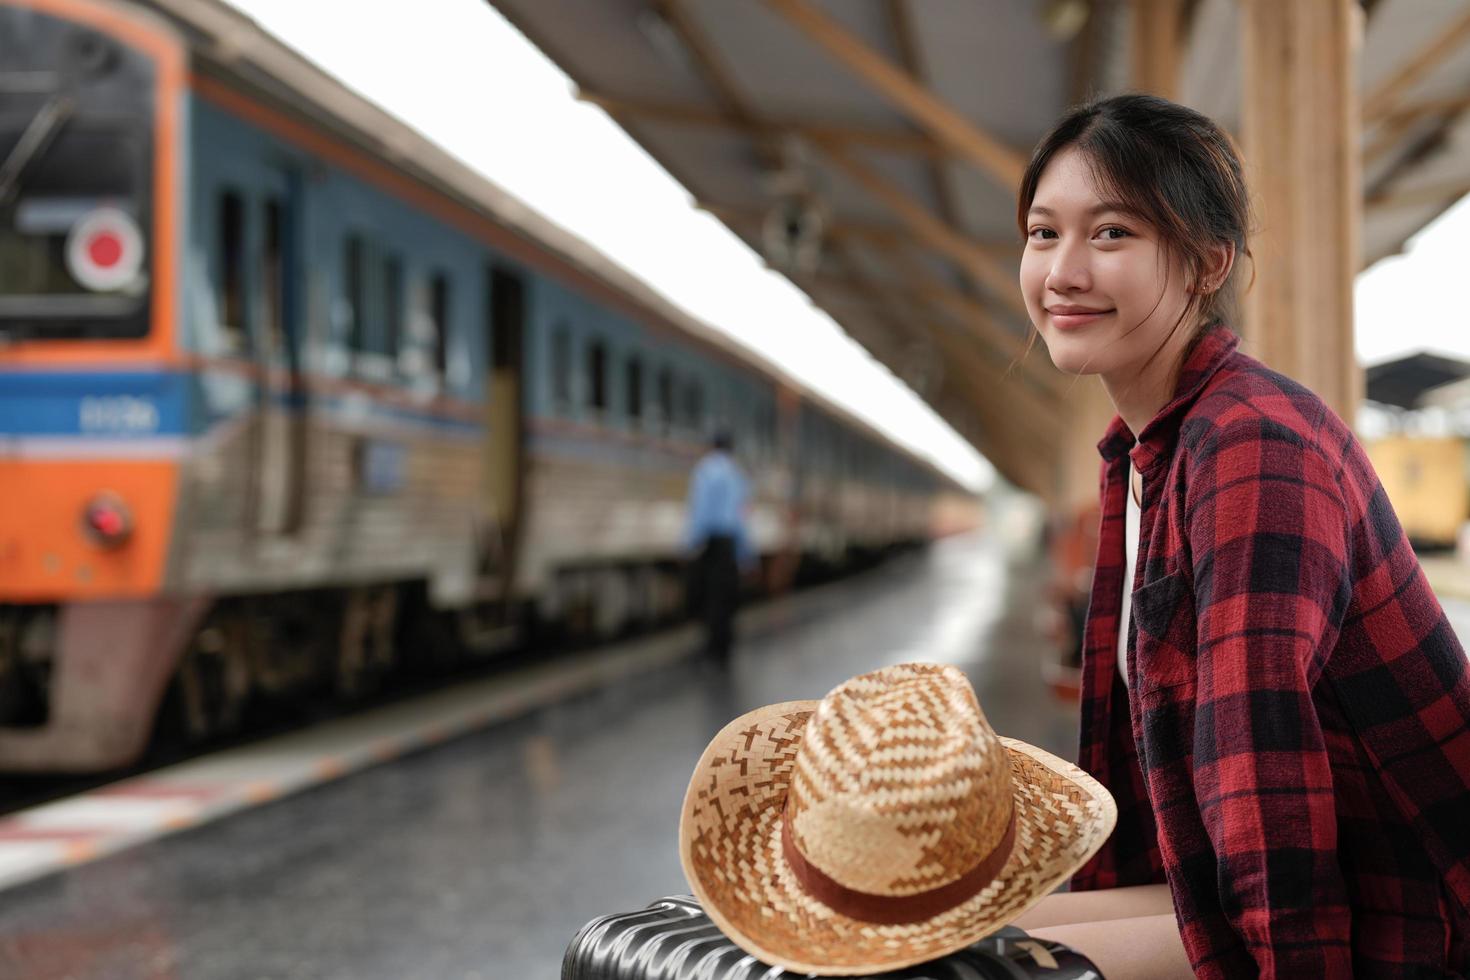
<box><xmin>1183</xmin><ymin>419</ymin><xmax>1352</xmax><ymax>979</ymax></box>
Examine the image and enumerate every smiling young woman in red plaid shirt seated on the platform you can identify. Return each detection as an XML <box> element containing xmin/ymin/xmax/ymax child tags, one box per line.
<box><xmin>1016</xmin><ymin>96</ymin><xmax>1470</xmax><ymax>980</ymax></box>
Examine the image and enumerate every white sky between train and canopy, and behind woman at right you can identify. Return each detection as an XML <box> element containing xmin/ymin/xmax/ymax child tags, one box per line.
<box><xmin>220</xmin><ymin>0</ymin><xmax>1470</xmax><ymax>489</ymax></box>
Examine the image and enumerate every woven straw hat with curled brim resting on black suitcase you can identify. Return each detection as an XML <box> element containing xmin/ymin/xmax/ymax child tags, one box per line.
<box><xmin>681</xmin><ymin>664</ymin><xmax>1117</xmax><ymax>976</ymax></box>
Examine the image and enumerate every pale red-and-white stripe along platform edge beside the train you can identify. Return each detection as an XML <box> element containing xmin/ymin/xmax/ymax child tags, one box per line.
<box><xmin>0</xmin><ymin>579</ymin><xmax>851</xmax><ymax>890</ymax></box>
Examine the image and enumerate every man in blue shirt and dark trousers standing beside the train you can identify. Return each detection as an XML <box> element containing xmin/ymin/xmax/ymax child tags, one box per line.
<box><xmin>684</xmin><ymin>430</ymin><xmax>756</xmax><ymax>669</ymax></box>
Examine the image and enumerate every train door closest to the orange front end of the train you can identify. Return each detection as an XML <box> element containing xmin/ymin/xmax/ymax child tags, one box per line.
<box><xmin>254</xmin><ymin>170</ymin><xmax>306</xmax><ymax>536</ymax></box>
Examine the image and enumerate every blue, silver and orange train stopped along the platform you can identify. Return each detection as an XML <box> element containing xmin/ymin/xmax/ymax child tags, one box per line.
<box><xmin>0</xmin><ymin>0</ymin><xmax>964</xmax><ymax>771</ymax></box>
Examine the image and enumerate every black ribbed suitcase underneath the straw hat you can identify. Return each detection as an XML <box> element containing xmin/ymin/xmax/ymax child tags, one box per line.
<box><xmin>562</xmin><ymin>895</ymin><xmax>1101</xmax><ymax>980</ymax></box>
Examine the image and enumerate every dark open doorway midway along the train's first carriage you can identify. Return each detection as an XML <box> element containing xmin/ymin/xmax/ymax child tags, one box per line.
<box><xmin>485</xmin><ymin>266</ymin><xmax>526</xmax><ymax>587</ymax></box>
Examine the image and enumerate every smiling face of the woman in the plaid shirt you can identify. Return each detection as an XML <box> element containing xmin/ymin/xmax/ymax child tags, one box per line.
<box><xmin>1020</xmin><ymin>148</ymin><xmax>1189</xmax><ymax>381</ymax></box>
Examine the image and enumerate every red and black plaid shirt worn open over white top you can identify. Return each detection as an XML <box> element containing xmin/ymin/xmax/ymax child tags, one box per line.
<box><xmin>1073</xmin><ymin>323</ymin><xmax>1470</xmax><ymax>980</ymax></box>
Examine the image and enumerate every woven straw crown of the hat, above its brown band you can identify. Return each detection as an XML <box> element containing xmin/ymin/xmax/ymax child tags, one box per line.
<box><xmin>786</xmin><ymin>664</ymin><xmax>1011</xmax><ymax>895</ymax></box>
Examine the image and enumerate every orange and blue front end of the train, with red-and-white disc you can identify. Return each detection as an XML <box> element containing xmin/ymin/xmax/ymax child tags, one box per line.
<box><xmin>0</xmin><ymin>4</ymin><xmax>201</xmax><ymax>768</ymax></box>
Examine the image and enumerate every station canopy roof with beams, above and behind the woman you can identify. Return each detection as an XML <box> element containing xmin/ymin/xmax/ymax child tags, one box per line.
<box><xmin>492</xmin><ymin>0</ymin><xmax>1470</xmax><ymax>489</ymax></box>
